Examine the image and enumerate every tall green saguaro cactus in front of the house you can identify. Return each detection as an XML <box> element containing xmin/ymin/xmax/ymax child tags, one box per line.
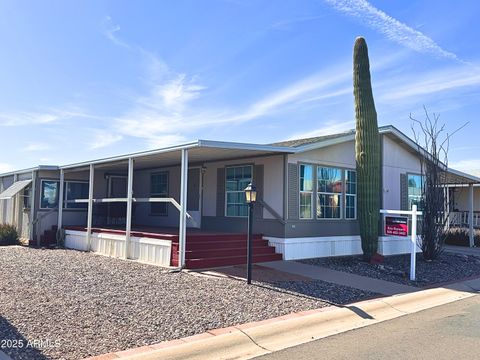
<box><xmin>353</xmin><ymin>37</ymin><xmax>380</xmax><ymax>260</ymax></box>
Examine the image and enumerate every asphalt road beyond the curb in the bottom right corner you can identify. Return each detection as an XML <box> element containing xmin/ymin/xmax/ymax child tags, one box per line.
<box><xmin>256</xmin><ymin>296</ymin><xmax>480</xmax><ymax>360</ymax></box>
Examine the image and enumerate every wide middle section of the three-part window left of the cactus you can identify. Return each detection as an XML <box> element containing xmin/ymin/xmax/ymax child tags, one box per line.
<box><xmin>317</xmin><ymin>167</ymin><xmax>343</xmax><ymax>219</ymax></box>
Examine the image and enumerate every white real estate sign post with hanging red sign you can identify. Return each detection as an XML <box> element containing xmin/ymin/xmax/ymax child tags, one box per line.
<box><xmin>380</xmin><ymin>205</ymin><xmax>422</xmax><ymax>281</ymax></box>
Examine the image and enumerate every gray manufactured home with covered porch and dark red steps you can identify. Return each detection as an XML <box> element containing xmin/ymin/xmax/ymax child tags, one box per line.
<box><xmin>0</xmin><ymin>126</ymin><xmax>480</xmax><ymax>268</ymax></box>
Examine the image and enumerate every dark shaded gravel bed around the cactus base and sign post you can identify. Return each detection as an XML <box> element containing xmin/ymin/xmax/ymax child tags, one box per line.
<box><xmin>299</xmin><ymin>252</ymin><xmax>480</xmax><ymax>287</ymax></box>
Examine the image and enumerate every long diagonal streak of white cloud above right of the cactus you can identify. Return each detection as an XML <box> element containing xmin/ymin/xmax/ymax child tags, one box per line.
<box><xmin>325</xmin><ymin>0</ymin><xmax>460</xmax><ymax>60</ymax></box>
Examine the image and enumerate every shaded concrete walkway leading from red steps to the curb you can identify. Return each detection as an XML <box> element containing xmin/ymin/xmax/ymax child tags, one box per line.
<box><xmin>260</xmin><ymin>260</ymin><xmax>420</xmax><ymax>295</ymax></box>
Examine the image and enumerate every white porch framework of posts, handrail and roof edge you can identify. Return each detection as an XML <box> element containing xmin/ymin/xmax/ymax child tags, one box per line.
<box><xmin>58</xmin><ymin>140</ymin><xmax>295</xmax><ymax>267</ymax></box>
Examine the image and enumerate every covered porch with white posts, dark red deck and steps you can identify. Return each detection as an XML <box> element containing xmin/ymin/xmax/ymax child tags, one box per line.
<box><xmin>56</xmin><ymin>141</ymin><xmax>289</xmax><ymax>268</ymax></box>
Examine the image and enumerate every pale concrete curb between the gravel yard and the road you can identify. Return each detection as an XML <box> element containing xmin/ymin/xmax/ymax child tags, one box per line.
<box><xmin>89</xmin><ymin>278</ymin><xmax>480</xmax><ymax>360</ymax></box>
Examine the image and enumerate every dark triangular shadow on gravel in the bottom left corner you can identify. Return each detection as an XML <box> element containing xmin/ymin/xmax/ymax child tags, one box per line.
<box><xmin>0</xmin><ymin>316</ymin><xmax>48</xmax><ymax>360</ymax></box>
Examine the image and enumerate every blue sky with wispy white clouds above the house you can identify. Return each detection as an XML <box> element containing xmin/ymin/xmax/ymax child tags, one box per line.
<box><xmin>0</xmin><ymin>0</ymin><xmax>480</xmax><ymax>173</ymax></box>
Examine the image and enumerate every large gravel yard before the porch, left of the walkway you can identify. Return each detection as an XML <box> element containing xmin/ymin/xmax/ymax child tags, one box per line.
<box><xmin>0</xmin><ymin>247</ymin><xmax>374</xmax><ymax>359</ymax></box>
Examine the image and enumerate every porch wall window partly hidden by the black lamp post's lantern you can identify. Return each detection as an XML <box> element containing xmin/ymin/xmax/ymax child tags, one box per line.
<box><xmin>225</xmin><ymin>166</ymin><xmax>252</xmax><ymax>217</ymax></box>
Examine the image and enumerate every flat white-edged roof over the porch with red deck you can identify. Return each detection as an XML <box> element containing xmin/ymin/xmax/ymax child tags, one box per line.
<box><xmin>59</xmin><ymin>140</ymin><xmax>296</xmax><ymax>170</ymax></box>
